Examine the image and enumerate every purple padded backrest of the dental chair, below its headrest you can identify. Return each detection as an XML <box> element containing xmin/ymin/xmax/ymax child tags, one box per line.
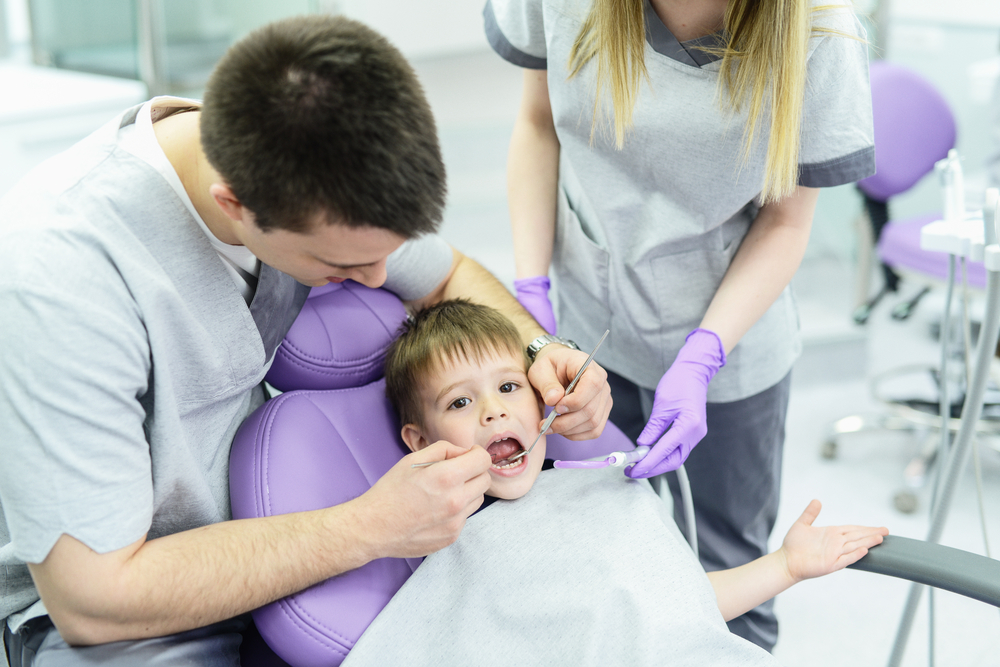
<box><xmin>229</xmin><ymin>381</ymin><xmax>420</xmax><ymax>667</ymax></box>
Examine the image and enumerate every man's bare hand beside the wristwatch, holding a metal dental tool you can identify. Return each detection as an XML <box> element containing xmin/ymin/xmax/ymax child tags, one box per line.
<box><xmin>528</xmin><ymin>343</ymin><xmax>612</xmax><ymax>440</ymax></box>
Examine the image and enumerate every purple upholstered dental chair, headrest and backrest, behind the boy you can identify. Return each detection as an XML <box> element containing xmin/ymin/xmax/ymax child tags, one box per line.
<box><xmin>230</xmin><ymin>281</ymin><xmax>635</xmax><ymax>667</ymax></box>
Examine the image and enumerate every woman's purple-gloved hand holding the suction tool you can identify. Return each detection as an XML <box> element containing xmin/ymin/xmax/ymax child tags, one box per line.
<box><xmin>625</xmin><ymin>329</ymin><xmax>726</xmax><ymax>478</ymax></box>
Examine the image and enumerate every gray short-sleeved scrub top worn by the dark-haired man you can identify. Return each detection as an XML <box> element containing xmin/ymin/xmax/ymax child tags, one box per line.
<box><xmin>0</xmin><ymin>102</ymin><xmax>452</xmax><ymax>640</ymax></box>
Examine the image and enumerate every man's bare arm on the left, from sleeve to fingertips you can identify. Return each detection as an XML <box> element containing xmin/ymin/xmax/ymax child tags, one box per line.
<box><xmin>29</xmin><ymin>443</ymin><xmax>490</xmax><ymax>645</ymax></box>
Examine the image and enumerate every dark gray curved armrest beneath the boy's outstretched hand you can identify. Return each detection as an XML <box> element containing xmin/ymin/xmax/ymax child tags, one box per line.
<box><xmin>848</xmin><ymin>535</ymin><xmax>1000</xmax><ymax>607</ymax></box>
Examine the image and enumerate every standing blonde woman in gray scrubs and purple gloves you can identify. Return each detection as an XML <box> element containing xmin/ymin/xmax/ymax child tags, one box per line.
<box><xmin>484</xmin><ymin>0</ymin><xmax>875</xmax><ymax>649</ymax></box>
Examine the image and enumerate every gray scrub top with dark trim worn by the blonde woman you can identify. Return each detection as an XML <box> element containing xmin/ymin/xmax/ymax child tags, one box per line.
<box><xmin>484</xmin><ymin>0</ymin><xmax>875</xmax><ymax>402</ymax></box>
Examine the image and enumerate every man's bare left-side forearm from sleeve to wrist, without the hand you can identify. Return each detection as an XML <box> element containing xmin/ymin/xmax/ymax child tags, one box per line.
<box><xmin>29</xmin><ymin>505</ymin><xmax>374</xmax><ymax>645</ymax></box>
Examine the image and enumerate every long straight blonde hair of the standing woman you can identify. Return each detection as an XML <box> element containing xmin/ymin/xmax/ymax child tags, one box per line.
<box><xmin>569</xmin><ymin>0</ymin><xmax>830</xmax><ymax>202</ymax></box>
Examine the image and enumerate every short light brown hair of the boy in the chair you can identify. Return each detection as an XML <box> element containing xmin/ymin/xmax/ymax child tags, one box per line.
<box><xmin>385</xmin><ymin>299</ymin><xmax>528</xmax><ymax>426</ymax></box>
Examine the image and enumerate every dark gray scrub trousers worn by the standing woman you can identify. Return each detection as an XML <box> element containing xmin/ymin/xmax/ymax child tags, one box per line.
<box><xmin>608</xmin><ymin>371</ymin><xmax>791</xmax><ymax>651</ymax></box>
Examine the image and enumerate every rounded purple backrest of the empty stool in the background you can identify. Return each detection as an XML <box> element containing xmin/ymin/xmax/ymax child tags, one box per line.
<box><xmin>858</xmin><ymin>60</ymin><xmax>955</xmax><ymax>202</ymax></box>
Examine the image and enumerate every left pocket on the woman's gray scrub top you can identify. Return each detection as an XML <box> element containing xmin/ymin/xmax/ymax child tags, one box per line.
<box><xmin>553</xmin><ymin>187</ymin><xmax>611</xmax><ymax>340</ymax></box>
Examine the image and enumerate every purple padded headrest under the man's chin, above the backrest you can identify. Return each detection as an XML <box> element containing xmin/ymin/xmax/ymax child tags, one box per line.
<box><xmin>266</xmin><ymin>280</ymin><xmax>406</xmax><ymax>391</ymax></box>
